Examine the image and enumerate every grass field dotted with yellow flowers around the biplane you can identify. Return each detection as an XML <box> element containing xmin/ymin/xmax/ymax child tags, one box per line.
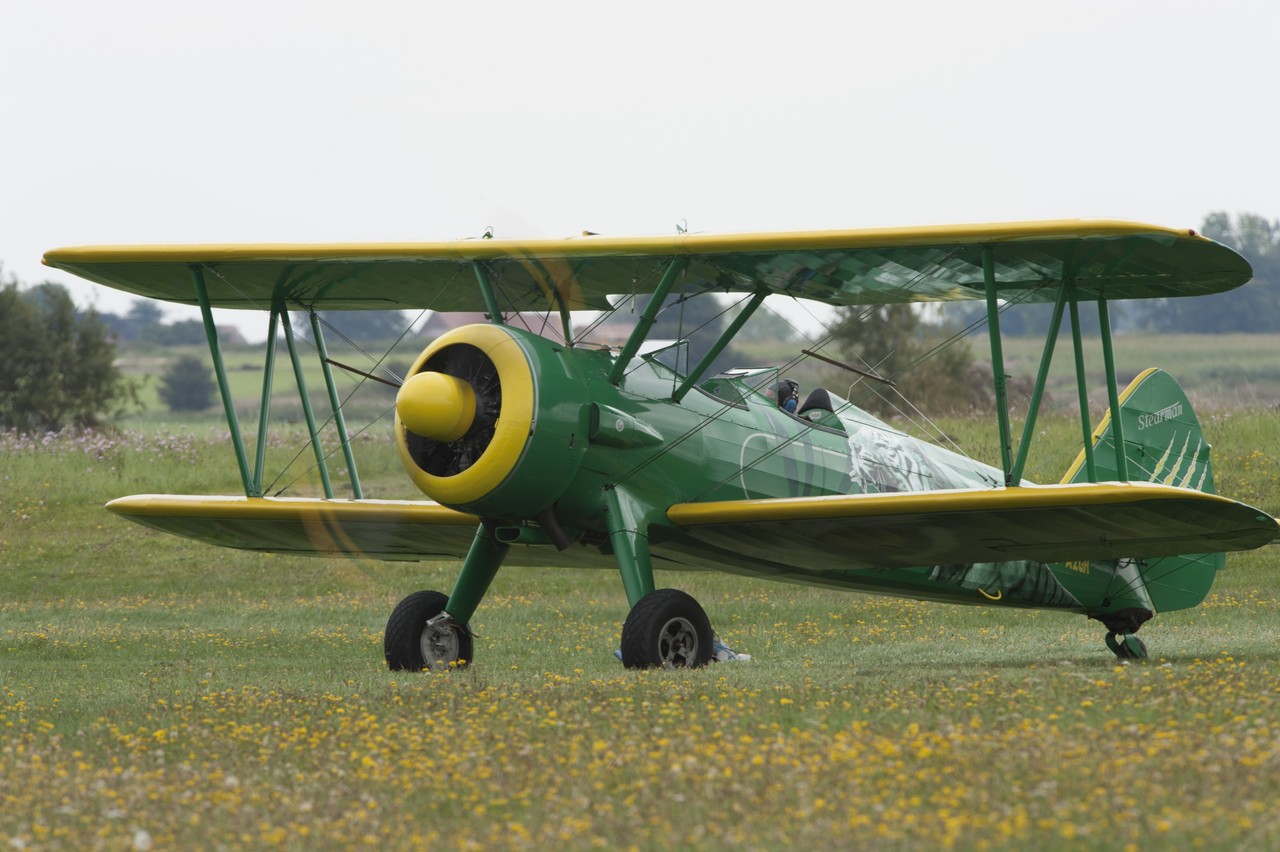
<box><xmin>0</xmin><ymin>408</ymin><xmax>1280</xmax><ymax>849</ymax></box>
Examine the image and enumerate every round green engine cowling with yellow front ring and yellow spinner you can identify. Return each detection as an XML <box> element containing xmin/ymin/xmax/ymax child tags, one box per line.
<box><xmin>396</xmin><ymin>319</ymin><xmax>589</xmax><ymax>519</ymax></box>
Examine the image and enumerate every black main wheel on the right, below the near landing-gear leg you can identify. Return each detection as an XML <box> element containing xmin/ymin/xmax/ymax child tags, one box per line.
<box><xmin>622</xmin><ymin>588</ymin><xmax>712</xmax><ymax>669</ymax></box>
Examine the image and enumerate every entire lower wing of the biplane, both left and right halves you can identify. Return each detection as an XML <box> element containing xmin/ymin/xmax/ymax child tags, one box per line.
<box><xmin>108</xmin><ymin>482</ymin><xmax>1280</xmax><ymax>574</ymax></box>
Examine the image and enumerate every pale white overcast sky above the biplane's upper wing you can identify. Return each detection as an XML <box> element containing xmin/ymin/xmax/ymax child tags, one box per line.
<box><xmin>0</xmin><ymin>0</ymin><xmax>1280</xmax><ymax>337</ymax></box>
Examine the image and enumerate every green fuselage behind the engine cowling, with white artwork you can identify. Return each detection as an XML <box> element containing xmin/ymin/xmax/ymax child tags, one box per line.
<box><xmin>486</xmin><ymin>327</ymin><xmax>1149</xmax><ymax>621</ymax></box>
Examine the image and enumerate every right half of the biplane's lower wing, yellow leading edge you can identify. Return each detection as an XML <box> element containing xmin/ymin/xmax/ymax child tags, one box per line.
<box><xmin>667</xmin><ymin>482</ymin><xmax>1280</xmax><ymax>572</ymax></box>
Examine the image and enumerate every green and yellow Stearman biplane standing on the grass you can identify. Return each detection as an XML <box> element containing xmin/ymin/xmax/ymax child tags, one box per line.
<box><xmin>45</xmin><ymin>221</ymin><xmax>1280</xmax><ymax>669</ymax></box>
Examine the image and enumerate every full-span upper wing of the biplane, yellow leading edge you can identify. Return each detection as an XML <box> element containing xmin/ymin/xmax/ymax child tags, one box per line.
<box><xmin>45</xmin><ymin>220</ymin><xmax>1252</xmax><ymax>311</ymax></box>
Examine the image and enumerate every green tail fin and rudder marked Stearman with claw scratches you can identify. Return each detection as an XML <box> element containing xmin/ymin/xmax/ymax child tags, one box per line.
<box><xmin>1062</xmin><ymin>367</ymin><xmax>1226</xmax><ymax>611</ymax></box>
